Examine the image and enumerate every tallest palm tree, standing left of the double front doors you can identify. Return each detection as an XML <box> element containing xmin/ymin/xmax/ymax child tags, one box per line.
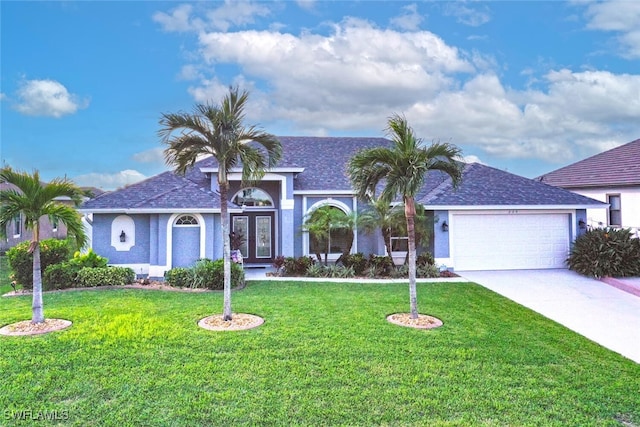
<box><xmin>158</xmin><ymin>88</ymin><xmax>282</xmax><ymax>321</ymax></box>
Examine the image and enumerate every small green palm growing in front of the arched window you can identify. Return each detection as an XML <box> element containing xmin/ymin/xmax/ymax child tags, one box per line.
<box><xmin>302</xmin><ymin>205</ymin><xmax>355</xmax><ymax>265</ymax></box>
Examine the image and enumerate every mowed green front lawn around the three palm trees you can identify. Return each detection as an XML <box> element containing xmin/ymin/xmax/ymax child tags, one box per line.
<box><xmin>0</xmin><ymin>256</ymin><xmax>640</xmax><ymax>426</ymax></box>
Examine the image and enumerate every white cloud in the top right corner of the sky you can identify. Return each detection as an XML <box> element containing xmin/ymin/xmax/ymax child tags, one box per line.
<box><xmin>586</xmin><ymin>0</ymin><xmax>640</xmax><ymax>58</ymax></box>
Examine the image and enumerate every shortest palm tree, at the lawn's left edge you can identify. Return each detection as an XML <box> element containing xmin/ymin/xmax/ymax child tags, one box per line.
<box><xmin>0</xmin><ymin>167</ymin><xmax>87</xmax><ymax>323</ymax></box>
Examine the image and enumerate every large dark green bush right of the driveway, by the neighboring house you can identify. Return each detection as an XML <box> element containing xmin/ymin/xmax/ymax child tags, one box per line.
<box><xmin>567</xmin><ymin>228</ymin><xmax>640</xmax><ymax>277</ymax></box>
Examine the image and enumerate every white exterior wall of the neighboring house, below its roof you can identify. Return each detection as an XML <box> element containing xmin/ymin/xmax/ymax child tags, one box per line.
<box><xmin>571</xmin><ymin>187</ymin><xmax>640</xmax><ymax>234</ymax></box>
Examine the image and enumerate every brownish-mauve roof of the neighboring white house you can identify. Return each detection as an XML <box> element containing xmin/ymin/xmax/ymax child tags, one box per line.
<box><xmin>538</xmin><ymin>139</ymin><xmax>640</xmax><ymax>188</ymax></box>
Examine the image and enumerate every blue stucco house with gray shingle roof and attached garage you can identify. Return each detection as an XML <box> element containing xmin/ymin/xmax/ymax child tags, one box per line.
<box><xmin>80</xmin><ymin>137</ymin><xmax>606</xmax><ymax>277</ymax></box>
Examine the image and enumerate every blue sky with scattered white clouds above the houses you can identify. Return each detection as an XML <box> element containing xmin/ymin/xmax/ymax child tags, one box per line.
<box><xmin>0</xmin><ymin>0</ymin><xmax>640</xmax><ymax>189</ymax></box>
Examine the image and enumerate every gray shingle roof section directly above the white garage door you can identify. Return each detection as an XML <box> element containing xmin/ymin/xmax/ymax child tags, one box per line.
<box><xmin>417</xmin><ymin>163</ymin><xmax>604</xmax><ymax>206</ymax></box>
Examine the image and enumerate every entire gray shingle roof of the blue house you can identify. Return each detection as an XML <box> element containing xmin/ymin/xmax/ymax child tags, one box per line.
<box><xmin>82</xmin><ymin>136</ymin><xmax>602</xmax><ymax>211</ymax></box>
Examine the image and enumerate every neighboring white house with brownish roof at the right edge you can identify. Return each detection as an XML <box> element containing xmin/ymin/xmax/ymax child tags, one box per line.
<box><xmin>538</xmin><ymin>139</ymin><xmax>640</xmax><ymax>235</ymax></box>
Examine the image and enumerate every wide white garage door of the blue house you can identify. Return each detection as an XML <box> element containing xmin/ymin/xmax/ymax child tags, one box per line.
<box><xmin>450</xmin><ymin>214</ymin><xmax>569</xmax><ymax>270</ymax></box>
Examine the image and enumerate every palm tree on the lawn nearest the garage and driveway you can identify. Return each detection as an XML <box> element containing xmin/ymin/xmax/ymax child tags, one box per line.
<box><xmin>348</xmin><ymin>114</ymin><xmax>462</xmax><ymax>319</ymax></box>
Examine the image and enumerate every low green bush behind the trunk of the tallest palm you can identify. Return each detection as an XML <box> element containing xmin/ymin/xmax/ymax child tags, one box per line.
<box><xmin>165</xmin><ymin>259</ymin><xmax>244</xmax><ymax>290</ymax></box>
